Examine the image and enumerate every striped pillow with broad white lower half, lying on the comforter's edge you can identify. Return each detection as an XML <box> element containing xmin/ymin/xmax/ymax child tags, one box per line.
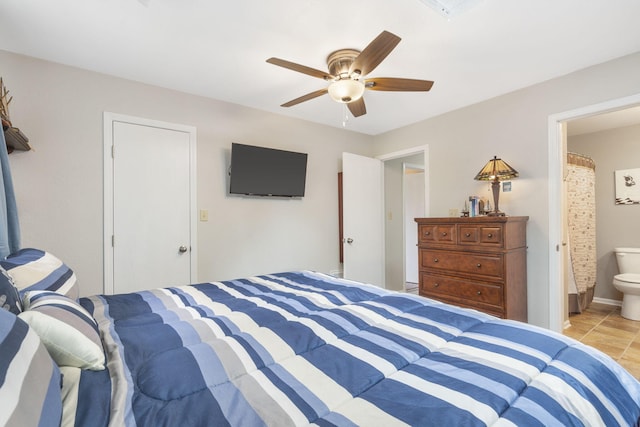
<box><xmin>19</xmin><ymin>291</ymin><xmax>105</xmax><ymax>371</ymax></box>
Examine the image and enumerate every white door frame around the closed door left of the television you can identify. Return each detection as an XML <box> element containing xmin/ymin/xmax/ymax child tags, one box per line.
<box><xmin>103</xmin><ymin>111</ymin><xmax>198</xmax><ymax>295</ymax></box>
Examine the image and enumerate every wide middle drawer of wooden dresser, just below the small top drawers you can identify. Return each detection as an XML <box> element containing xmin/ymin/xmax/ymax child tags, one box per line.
<box><xmin>420</xmin><ymin>249</ymin><xmax>504</xmax><ymax>280</ymax></box>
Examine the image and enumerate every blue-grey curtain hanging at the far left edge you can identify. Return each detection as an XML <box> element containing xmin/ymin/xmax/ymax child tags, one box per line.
<box><xmin>0</xmin><ymin>132</ymin><xmax>20</xmax><ymax>258</ymax></box>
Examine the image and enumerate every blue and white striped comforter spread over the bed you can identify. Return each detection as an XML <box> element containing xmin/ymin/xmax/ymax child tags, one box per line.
<box><xmin>76</xmin><ymin>272</ymin><xmax>640</xmax><ymax>427</ymax></box>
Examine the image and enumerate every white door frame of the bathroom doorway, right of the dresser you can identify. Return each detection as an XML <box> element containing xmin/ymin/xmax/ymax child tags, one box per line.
<box><xmin>548</xmin><ymin>94</ymin><xmax>640</xmax><ymax>332</ymax></box>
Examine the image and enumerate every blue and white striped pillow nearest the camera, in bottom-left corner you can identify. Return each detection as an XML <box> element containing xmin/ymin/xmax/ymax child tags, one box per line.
<box><xmin>0</xmin><ymin>310</ymin><xmax>62</xmax><ymax>426</ymax></box>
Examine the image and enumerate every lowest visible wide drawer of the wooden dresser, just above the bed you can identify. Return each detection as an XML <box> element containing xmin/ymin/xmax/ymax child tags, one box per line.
<box><xmin>420</xmin><ymin>273</ymin><xmax>504</xmax><ymax>307</ymax></box>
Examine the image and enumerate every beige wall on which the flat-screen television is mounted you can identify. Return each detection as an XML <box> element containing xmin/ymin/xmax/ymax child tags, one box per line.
<box><xmin>0</xmin><ymin>51</ymin><xmax>372</xmax><ymax>295</ymax></box>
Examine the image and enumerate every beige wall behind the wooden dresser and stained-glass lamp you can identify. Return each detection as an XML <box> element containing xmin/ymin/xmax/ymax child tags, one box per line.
<box><xmin>375</xmin><ymin>53</ymin><xmax>640</xmax><ymax>326</ymax></box>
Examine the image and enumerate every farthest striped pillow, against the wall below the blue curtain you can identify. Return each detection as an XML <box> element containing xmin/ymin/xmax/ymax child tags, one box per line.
<box><xmin>0</xmin><ymin>248</ymin><xmax>78</xmax><ymax>299</ymax></box>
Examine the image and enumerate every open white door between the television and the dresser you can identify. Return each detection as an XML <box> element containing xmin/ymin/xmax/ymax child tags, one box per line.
<box><xmin>342</xmin><ymin>153</ymin><xmax>384</xmax><ymax>287</ymax></box>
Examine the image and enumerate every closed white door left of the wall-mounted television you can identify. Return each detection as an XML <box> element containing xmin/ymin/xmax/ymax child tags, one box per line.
<box><xmin>105</xmin><ymin>113</ymin><xmax>195</xmax><ymax>293</ymax></box>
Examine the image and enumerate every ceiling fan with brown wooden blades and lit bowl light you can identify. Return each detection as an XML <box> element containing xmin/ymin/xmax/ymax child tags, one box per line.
<box><xmin>267</xmin><ymin>31</ymin><xmax>433</xmax><ymax>117</ymax></box>
